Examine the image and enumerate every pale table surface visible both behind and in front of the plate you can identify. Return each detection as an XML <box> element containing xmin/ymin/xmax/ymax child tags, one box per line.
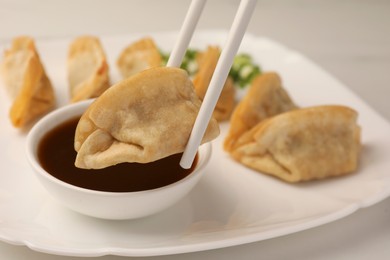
<box><xmin>0</xmin><ymin>0</ymin><xmax>390</xmax><ymax>260</ymax></box>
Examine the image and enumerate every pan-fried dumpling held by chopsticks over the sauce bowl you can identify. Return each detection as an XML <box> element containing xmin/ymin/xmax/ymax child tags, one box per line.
<box><xmin>75</xmin><ymin>67</ymin><xmax>219</xmax><ymax>169</ymax></box>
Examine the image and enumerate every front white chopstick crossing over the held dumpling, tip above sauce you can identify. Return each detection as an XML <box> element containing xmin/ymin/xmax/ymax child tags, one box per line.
<box><xmin>180</xmin><ymin>0</ymin><xmax>256</xmax><ymax>169</ymax></box>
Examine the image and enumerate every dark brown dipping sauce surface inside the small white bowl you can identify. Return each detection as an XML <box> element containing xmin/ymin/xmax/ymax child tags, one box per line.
<box><xmin>38</xmin><ymin>117</ymin><xmax>197</xmax><ymax>192</ymax></box>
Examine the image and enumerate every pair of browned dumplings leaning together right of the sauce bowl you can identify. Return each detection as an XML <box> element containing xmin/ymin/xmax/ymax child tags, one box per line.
<box><xmin>224</xmin><ymin>70</ymin><xmax>361</xmax><ymax>182</ymax></box>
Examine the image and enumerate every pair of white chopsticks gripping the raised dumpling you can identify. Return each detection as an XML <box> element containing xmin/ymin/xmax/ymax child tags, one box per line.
<box><xmin>167</xmin><ymin>0</ymin><xmax>256</xmax><ymax>169</ymax></box>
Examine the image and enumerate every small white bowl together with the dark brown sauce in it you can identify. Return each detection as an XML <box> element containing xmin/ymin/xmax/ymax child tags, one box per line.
<box><xmin>26</xmin><ymin>100</ymin><xmax>211</xmax><ymax>219</ymax></box>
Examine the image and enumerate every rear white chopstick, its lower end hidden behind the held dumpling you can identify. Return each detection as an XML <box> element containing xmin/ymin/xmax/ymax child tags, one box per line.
<box><xmin>167</xmin><ymin>0</ymin><xmax>206</xmax><ymax>67</ymax></box>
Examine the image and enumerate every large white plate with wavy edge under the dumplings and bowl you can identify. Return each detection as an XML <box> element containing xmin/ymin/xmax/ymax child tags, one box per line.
<box><xmin>0</xmin><ymin>31</ymin><xmax>390</xmax><ymax>256</ymax></box>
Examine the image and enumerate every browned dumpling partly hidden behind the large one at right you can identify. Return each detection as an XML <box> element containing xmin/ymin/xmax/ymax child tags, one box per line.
<box><xmin>224</xmin><ymin>72</ymin><xmax>297</xmax><ymax>151</ymax></box>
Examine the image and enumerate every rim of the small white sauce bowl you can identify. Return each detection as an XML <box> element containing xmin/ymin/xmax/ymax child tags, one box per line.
<box><xmin>25</xmin><ymin>99</ymin><xmax>212</xmax><ymax>196</ymax></box>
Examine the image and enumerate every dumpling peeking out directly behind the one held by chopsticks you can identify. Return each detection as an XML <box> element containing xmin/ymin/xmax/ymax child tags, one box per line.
<box><xmin>117</xmin><ymin>38</ymin><xmax>162</xmax><ymax>78</ymax></box>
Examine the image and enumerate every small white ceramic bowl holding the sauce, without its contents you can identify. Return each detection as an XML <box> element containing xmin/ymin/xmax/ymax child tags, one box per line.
<box><xmin>26</xmin><ymin>100</ymin><xmax>211</xmax><ymax>219</ymax></box>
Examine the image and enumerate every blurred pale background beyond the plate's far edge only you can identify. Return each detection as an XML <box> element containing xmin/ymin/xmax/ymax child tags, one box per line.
<box><xmin>0</xmin><ymin>0</ymin><xmax>390</xmax><ymax>119</ymax></box>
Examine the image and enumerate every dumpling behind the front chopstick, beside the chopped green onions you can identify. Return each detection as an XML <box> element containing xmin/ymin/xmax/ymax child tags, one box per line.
<box><xmin>193</xmin><ymin>47</ymin><xmax>236</xmax><ymax>121</ymax></box>
